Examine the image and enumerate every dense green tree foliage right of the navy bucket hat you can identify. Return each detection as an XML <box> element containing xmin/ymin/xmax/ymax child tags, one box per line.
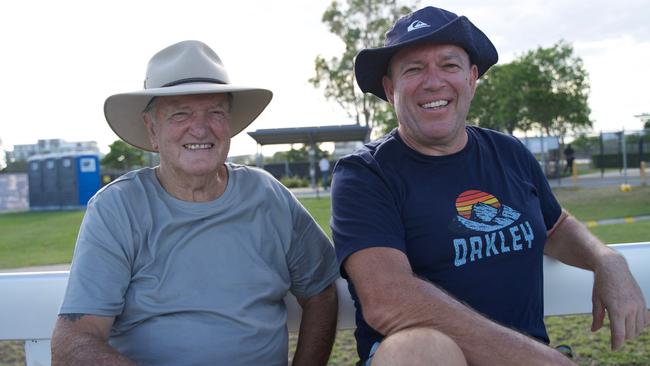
<box><xmin>468</xmin><ymin>41</ymin><xmax>592</xmax><ymax>136</ymax></box>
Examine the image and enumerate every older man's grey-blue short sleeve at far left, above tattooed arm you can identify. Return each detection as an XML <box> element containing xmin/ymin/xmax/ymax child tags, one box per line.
<box><xmin>59</xmin><ymin>191</ymin><xmax>133</xmax><ymax>316</ymax></box>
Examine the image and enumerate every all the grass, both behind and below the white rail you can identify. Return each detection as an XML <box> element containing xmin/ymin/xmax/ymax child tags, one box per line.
<box><xmin>0</xmin><ymin>187</ymin><xmax>650</xmax><ymax>366</ymax></box>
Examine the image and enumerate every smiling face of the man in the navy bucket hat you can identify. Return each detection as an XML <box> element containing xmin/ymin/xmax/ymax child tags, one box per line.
<box><xmin>383</xmin><ymin>44</ymin><xmax>478</xmax><ymax>155</ymax></box>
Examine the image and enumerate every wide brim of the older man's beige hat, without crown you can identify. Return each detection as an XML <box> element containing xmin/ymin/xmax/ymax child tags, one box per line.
<box><xmin>104</xmin><ymin>83</ymin><xmax>273</xmax><ymax>151</ymax></box>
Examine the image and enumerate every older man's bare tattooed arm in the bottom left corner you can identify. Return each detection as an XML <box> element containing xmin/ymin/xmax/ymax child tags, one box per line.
<box><xmin>52</xmin><ymin>314</ymin><xmax>136</xmax><ymax>366</ymax></box>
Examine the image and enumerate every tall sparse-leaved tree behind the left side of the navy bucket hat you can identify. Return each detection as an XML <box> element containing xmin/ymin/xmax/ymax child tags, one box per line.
<box><xmin>309</xmin><ymin>0</ymin><xmax>411</xmax><ymax>135</ymax></box>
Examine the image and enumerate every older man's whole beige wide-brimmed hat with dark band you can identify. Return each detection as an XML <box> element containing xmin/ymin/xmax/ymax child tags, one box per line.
<box><xmin>104</xmin><ymin>41</ymin><xmax>273</xmax><ymax>151</ymax></box>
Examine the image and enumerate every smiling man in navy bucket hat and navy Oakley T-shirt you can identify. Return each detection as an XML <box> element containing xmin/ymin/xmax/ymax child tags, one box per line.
<box><xmin>331</xmin><ymin>7</ymin><xmax>648</xmax><ymax>365</ymax></box>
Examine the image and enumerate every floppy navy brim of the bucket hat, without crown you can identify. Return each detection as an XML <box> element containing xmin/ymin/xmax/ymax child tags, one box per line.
<box><xmin>354</xmin><ymin>16</ymin><xmax>499</xmax><ymax>100</ymax></box>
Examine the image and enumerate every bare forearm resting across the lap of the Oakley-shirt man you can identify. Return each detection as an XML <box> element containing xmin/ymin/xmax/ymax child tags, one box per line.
<box><xmin>344</xmin><ymin>247</ymin><xmax>573</xmax><ymax>366</ymax></box>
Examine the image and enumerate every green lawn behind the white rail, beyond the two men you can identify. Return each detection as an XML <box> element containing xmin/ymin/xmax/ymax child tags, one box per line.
<box><xmin>0</xmin><ymin>187</ymin><xmax>650</xmax><ymax>268</ymax></box>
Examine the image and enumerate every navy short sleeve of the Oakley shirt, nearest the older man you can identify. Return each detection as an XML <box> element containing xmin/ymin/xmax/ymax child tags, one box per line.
<box><xmin>331</xmin><ymin>155</ymin><xmax>406</xmax><ymax>277</ymax></box>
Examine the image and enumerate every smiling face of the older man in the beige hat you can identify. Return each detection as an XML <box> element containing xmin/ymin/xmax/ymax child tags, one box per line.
<box><xmin>144</xmin><ymin>94</ymin><xmax>230</xmax><ymax>177</ymax></box>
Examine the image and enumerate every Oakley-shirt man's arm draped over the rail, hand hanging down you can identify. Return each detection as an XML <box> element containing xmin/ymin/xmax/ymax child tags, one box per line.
<box><xmin>544</xmin><ymin>211</ymin><xmax>650</xmax><ymax>350</ymax></box>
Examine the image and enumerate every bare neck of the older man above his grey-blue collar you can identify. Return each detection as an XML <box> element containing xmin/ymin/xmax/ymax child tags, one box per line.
<box><xmin>156</xmin><ymin>164</ymin><xmax>228</xmax><ymax>202</ymax></box>
